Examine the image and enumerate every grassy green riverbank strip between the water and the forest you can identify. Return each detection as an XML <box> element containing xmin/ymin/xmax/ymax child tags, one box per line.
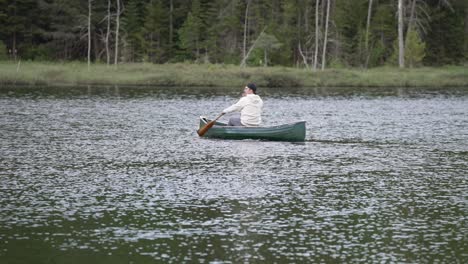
<box><xmin>0</xmin><ymin>62</ymin><xmax>468</xmax><ymax>87</ymax></box>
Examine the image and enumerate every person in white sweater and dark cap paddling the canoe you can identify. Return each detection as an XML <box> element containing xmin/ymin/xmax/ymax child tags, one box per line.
<box><xmin>222</xmin><ymin>83</ymin><xmax>263</xmax><ymax>126</ymax></box>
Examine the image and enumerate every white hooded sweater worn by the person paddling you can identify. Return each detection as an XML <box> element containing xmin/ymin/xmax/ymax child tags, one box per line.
<box><xmin>223</xmin><ymin>94</ymin><xmax>263</xmax><ymax>126</ymax></box>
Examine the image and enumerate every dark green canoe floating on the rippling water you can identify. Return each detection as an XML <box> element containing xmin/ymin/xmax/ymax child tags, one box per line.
<box><xmin>200</xmin><ymin>116</ymin><xmax>306</xmax><ymax>141</ymax></box>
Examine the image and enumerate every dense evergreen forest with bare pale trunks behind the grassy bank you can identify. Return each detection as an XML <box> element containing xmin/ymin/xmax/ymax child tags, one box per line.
<box><xmin>0</xmin><ymin>0</ymin><xmax>468</xmax><ymax>69</ymax></box>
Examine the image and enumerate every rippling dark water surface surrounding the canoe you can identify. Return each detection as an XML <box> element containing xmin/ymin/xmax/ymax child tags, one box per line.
<box><xmin>0</xmin><ymin>87</ymin><xmax>468</xmax><ymax>263</ymax></box>
